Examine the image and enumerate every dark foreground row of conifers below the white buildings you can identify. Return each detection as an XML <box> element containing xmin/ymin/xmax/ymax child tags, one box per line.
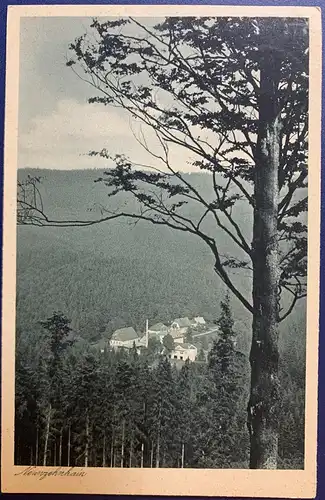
<box><xmin>15</xmin><ymin>301</ymin><xmax>304</xmax><ymax>468</ymax></box>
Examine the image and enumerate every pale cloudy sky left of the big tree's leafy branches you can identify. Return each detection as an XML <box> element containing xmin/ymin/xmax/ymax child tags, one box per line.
<box><xmin>18</xmin><ymin>17</ymin><xmax>197</xmax><ymax>170</ymax></box>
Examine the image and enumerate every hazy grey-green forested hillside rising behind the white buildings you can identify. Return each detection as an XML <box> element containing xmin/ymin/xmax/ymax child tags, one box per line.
<box><xmin>17</xmin><ymin>169</ymin><xmax>304</xmax><ymax>348</ymax></box>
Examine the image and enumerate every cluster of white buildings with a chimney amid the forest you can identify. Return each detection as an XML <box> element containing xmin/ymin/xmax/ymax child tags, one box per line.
<box><xmin>90</xmin><ymin>316</ymin><xmax>206</xmax><ymax>361</ymax></box>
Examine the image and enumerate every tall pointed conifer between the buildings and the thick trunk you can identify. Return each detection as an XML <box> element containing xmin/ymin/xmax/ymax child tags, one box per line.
<box><xmin>195</xmin><ymin>295</ymin><xmax>248</xmax><ymax>467</ymax></box>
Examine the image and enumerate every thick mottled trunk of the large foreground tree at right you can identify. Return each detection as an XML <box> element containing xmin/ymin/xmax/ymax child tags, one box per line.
<box><xmin>248</xmin><ymin>51</ymin><xmax>281</xmax><ymax>469</ymax></box>
